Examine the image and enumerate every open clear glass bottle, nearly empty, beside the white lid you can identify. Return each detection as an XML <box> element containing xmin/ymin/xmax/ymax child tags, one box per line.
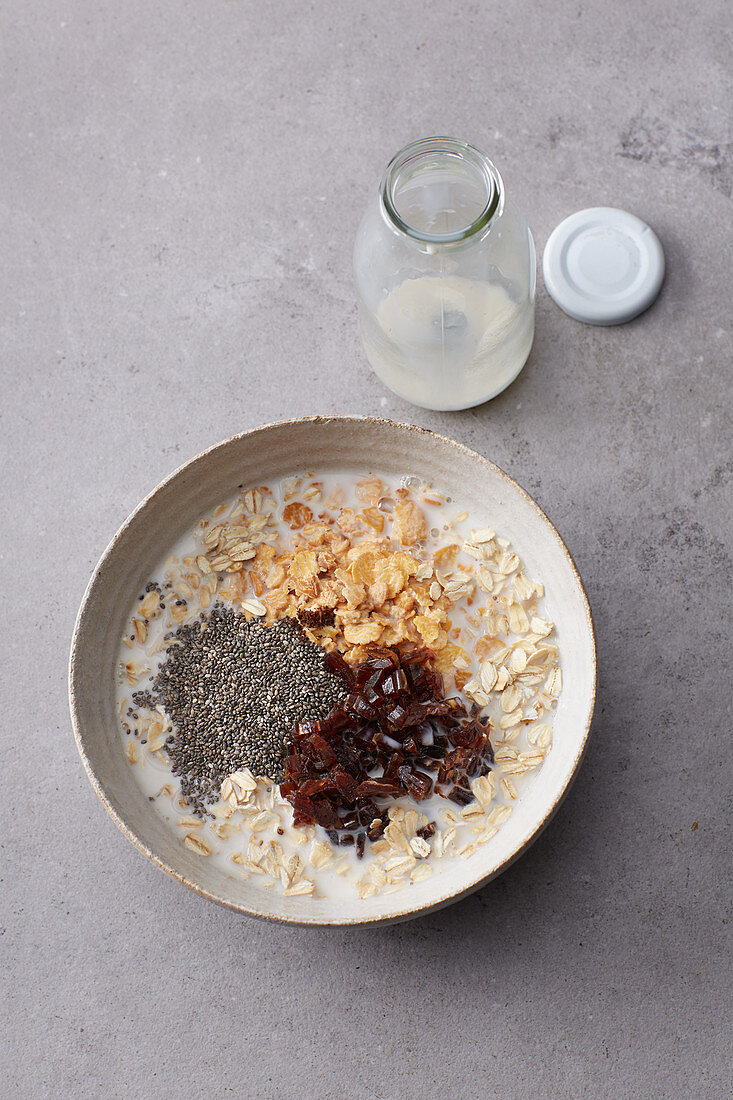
<box><xmin>353</xmin><ymin>138</ymin><xmax>535</xmax><ymax>409</ymax></box>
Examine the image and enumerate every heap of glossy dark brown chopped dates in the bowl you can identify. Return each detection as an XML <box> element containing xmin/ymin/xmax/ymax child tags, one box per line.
<box><xmin>281</xmin><ymin>646</ymin><xmax>494</xmax><ymax>857</ymax></box>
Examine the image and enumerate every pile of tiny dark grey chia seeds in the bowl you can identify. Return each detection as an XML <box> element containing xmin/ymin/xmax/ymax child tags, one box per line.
<box><xmin>133</xmin><ymin>604</ymin><xmax>347</xmax><ymax>814</ymax></box>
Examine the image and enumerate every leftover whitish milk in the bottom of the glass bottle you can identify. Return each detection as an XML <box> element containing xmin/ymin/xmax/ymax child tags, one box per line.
<box><xmin>362</xmin><ymin>275</ymin><xmax>535</xmax><ymax>409</ymax></box>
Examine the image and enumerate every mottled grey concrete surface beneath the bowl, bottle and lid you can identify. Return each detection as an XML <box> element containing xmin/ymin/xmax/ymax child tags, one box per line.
<box><xmin>0</xmin><ymin>0</ymin><xmax>733</xmax><ymax>1100</ymax></box>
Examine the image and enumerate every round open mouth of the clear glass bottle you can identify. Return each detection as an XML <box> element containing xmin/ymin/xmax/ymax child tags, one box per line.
<box><xmin>382</xmin><ymin>138</ymin><xmax>502</xmax><ymax>244</ymax></box>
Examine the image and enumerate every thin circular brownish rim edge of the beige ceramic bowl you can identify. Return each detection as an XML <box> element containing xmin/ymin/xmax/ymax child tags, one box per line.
<box><xmin>68</xmin><ymin>414</ymin><xmax>598</xmax><ymax>928</ymax></box>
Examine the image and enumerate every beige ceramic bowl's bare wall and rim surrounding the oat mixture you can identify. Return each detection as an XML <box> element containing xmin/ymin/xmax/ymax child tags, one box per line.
<box><xmin>69</xmin><ymin>416</ymin><xmax>595</xmax><ymax>925</ymax></box>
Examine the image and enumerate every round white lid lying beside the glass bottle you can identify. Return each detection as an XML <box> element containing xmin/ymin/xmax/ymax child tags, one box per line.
<box><xmin>543</xmin><ymin>207</ymin><xmax>665</xmax><ymax>325</ymax></box>
